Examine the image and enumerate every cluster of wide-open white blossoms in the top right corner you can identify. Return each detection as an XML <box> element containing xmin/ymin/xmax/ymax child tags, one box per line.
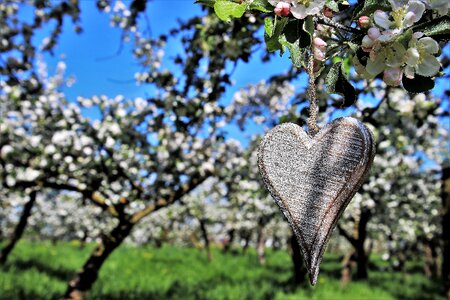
<box><xmin>353</xmin><ymin>0</ymin><xmax>441</xmax><ymax>86</ymax></box>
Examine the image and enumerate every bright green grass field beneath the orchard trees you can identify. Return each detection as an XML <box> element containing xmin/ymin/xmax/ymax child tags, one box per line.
<box><xmin>0</xmin><ymin>241</ymin><xmax>443</xmax><ymax>300</ymax></box>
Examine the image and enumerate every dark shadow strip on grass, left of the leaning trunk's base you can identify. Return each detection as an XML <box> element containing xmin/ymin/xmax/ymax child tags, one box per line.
<box><xmin>3</xmin><ymin>259</ymin><xmax>75</xmax><ymax>281</ymax></box>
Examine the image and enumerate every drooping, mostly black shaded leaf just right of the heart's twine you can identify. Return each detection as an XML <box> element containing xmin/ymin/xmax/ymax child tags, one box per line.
<box><xmin>325</xmin><ymin>62</ymin><xmax>356</xmax><ymax>107</ymax></box>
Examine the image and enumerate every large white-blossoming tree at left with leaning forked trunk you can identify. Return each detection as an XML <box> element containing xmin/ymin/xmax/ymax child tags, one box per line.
<box><xmin>0</xmin><ymin>1</ymin><xmax>284</xmax><ymax>298</ymax></box>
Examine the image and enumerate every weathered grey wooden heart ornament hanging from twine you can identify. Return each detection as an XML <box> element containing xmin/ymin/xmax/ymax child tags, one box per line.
<box><xmin>258</xmin><ymin>118</ymin><xmax>375</xmax><ymax>285</ymax></box>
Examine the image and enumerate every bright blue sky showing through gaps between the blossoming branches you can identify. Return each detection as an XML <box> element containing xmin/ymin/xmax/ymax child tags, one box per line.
<box><xmin>16</xmin><ymin>0</ymin><xmax>448</xmax><ymax>149</ymax></box>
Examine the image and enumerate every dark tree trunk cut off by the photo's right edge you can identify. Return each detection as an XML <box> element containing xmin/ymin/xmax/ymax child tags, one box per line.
<box><xmin>441</xmin><ymin>166</ymin><xmax>450</xmax><ymax>299</ymax></box>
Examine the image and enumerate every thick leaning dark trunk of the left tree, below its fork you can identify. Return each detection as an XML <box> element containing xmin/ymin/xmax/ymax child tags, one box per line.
<box><xmin>64</xmin><ymin>221</ymin><xmax>133</xmax><ymax>300</ymax></box>
